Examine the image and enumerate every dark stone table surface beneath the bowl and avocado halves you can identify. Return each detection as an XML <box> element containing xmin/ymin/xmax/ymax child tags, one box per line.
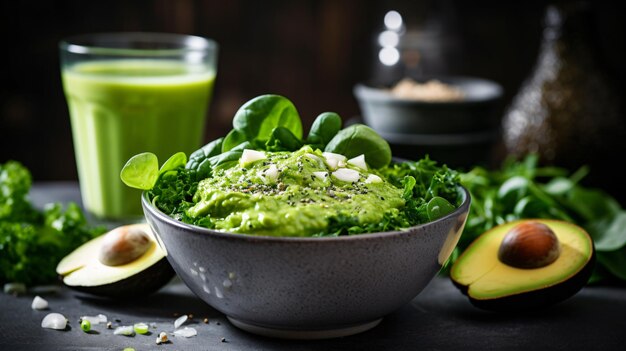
<box><xmin>0</xmin><ymin>182</ymin><xmax>626</xmax><ymax>351</ymax></box>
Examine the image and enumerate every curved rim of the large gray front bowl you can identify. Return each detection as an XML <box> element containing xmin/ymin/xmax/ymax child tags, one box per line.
<box><xmin>141</xmin><ymin>184</ymin><xmax>472</xmax><ymax>243</ymax></box>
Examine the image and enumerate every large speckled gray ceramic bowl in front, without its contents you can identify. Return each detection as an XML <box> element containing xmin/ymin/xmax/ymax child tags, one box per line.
<box><xmin>142</xmin><ymin>189</ymin><xmax>470</xmax><ymax>339</ymax></box>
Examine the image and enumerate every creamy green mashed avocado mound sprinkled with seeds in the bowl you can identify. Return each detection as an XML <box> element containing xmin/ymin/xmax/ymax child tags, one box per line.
<box><xmin>187</xmin><ymin>147</ymin><xmax>404</xmax><ymax>236</ymax></box>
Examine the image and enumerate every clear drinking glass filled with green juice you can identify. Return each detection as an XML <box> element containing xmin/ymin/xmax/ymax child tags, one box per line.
<box><xmin>59</xmin><ymin>33</ymin><xmax>218</xmax><ymax>220</ymax></box>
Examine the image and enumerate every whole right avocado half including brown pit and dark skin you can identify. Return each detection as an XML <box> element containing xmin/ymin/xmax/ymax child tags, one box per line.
<box><xmin>450</xmin><ymin>219</ymin><xmax>595</xmax><ymax>312</ymax></box>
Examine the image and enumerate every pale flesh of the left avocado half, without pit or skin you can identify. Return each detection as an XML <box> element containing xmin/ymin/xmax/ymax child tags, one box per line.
<box><xmin>56</xmin><ymin>224</ymin><xmax>172</xmax><ymax>293</ymax></box>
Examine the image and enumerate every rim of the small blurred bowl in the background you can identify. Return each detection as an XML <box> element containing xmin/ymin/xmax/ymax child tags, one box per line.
<box><xmin>353</xmin><ymin>76</ymin><xmax>504</xmax><ymax>106</ymax></box>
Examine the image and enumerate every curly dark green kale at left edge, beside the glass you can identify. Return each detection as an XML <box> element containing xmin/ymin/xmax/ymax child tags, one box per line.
<box><xmin>0</xmin><ymin>161</ymin><xmax>105</xmax><ymax>285</ymax></box>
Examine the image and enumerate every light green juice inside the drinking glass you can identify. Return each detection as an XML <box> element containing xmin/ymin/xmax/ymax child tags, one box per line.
<box><xmin>63</xmin><ymin>59</ymin><xmax>215</xmax><ymax>219</ymax></box>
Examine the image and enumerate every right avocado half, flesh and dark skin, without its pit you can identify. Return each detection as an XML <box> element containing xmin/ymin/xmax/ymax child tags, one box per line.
<box><xmin>450</xmin><ymin>219</ymin><xmax>595</xmax><ymax>311</ymax></box>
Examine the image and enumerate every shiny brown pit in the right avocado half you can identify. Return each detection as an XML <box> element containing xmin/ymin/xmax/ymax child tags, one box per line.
<box><xmin>498</xmin><ymin>221</ymin><xmax>561</xmax><ymax>269</ymax></box>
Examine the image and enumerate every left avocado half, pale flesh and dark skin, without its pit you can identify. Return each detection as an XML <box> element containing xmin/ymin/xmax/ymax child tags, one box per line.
<box><xmin>56</xmin><ymin>224</ymin><xmax>175</xmax><ymax>298</ymax></box>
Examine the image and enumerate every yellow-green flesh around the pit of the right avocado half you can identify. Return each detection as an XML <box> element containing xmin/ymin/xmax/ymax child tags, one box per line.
<box><xmin>450</xmin><ymin>220</ymin><xmax>593</xmax><ymax>300</ymax></box>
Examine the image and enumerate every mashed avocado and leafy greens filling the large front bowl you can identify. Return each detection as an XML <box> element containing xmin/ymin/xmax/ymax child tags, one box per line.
<box><xmin>120</xmin><ymin>94</ymin><xmax>463</xmax><ymax>237</ymax></box>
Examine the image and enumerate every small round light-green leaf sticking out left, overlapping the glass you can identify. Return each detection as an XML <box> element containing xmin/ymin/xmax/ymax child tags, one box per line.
<box><xmin>120</xmin><ymin>152</ymin><xmax>159</xmax><ymax>190</ymax></box>
